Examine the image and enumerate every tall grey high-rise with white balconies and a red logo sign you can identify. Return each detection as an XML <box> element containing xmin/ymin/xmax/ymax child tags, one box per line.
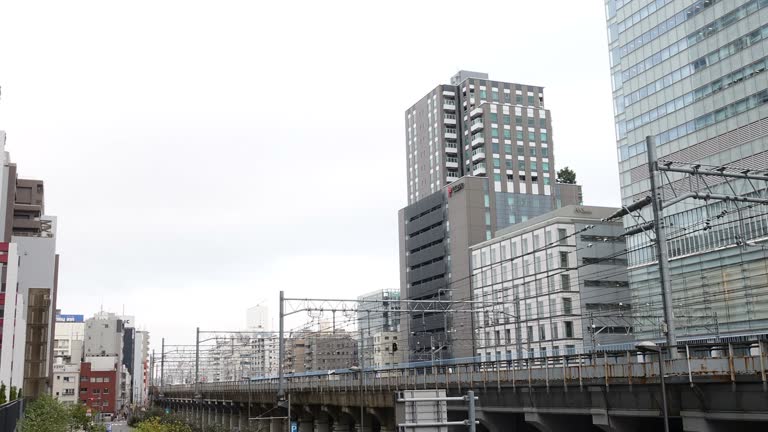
<box><xmin>399</xmin><ymin>71</ymin><xmax>582</xmax><ymax>360</ymax></box>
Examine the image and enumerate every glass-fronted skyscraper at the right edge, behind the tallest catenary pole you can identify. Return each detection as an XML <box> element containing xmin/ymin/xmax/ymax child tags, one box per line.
<box><xmin>605</xmin><ymin>0</ymin><xmax>768</xmax><ymax>338</ymax></box>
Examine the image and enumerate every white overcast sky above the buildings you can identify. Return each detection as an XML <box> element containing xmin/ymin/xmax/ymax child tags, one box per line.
<box><xmin>0</xmin><ymin>0</ymin><xmax>618</xmax><ymax>347</ymax></box>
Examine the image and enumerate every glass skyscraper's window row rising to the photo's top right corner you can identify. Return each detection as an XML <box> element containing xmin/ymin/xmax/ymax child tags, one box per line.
<box><xmin>621</xmin><ymin>0</ymin><xmax>768</xmax><ymax>81</ymax></box>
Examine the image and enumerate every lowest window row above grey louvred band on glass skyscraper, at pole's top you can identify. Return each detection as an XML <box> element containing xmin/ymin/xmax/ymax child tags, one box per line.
<box><xmin>619</xmin><ymin>90</ymin><xmax>768</xmax><ymax>160</ymax></box>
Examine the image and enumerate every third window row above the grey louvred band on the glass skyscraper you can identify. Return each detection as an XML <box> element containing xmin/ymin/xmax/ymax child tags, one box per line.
<box><xmin>616</xmin><ymin>25</ymin><xmax>768</xmax><ymax>114</ymax></box>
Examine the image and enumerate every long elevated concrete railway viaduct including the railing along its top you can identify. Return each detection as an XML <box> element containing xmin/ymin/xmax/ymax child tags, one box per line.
<box><xmin>157</xmin><ymin>341</ymin><xmax>768</xmax><ymax>432</ymax></box>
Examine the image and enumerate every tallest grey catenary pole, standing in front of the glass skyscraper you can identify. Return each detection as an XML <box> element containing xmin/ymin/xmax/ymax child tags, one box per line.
<box><xmin>645</xmin><ymin>136</ymin><xmax>677</xmax><ymax>358</ymax></box>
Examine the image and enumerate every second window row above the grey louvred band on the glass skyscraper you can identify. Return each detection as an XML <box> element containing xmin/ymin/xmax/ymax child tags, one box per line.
<box><xmin>626</xmin><ymin>55</ymin><xmax>768</xmax><ymax>136</ymax></box>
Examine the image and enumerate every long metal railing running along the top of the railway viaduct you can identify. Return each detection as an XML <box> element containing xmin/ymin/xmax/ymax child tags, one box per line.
<box><xmin>162</xmin><ymin>341</ymin><xmax>768</xmax><ymax>397</ymax></box>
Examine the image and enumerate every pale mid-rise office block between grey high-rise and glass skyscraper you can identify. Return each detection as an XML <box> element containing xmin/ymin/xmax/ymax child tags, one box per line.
<box><xmin>470</xmin><ymin>206</ymin><xmax>633</xmax><ymax>360</ymax></box>
